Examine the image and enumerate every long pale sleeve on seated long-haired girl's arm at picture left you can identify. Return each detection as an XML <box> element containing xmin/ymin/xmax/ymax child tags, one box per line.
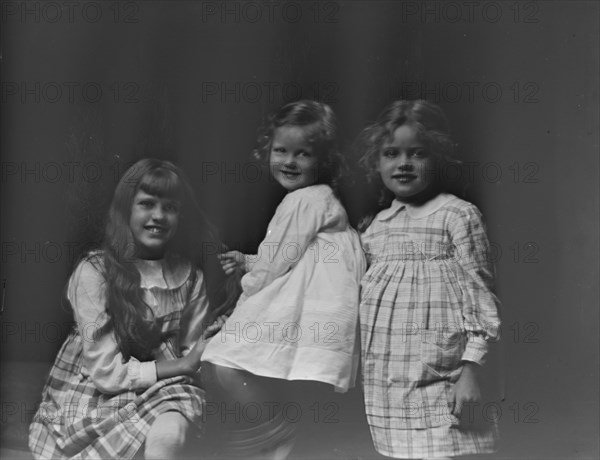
<box><xmin>67</xmin><ymin>260</ymin><xmax>157</xmax><ymax>394</ymax></box>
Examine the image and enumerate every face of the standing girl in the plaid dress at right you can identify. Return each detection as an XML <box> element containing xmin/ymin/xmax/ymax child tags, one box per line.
<box><xmin>377</xmin><ymin>125</ymin><xmax>437</xmax><ymax>202</ymax></box>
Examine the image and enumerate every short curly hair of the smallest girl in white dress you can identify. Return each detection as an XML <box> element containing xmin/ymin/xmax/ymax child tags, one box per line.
<box><xmin>253</xmin><ymin>100</ymin><xmax>346</xmax><ymax>189</ymax></box>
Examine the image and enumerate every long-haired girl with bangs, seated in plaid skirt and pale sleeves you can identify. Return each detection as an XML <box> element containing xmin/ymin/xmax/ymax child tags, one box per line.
<box><xmin>29</xmin><ymin>159</ymin><xmax>230</xmax><ymax>459</ymax></box>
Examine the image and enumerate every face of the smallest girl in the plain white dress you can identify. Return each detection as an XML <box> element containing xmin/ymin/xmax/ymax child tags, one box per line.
<box><xmin>269</xmin><ymin>126</ymin><xmax>318</xmax><ymax>192</ymax></box>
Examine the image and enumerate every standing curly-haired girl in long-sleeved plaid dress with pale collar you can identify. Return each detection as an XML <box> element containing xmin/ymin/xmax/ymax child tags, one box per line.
<box><xmin>360</xmin><ymin>101</ymin><xmax>500</xmax><ymax>459</ymax></box>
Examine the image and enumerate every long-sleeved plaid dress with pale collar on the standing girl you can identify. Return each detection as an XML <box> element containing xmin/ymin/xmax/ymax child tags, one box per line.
<box><xmin>360</xmin><ymin>194</ymin><xmax>500</xmax><ymax>458</ymax></box>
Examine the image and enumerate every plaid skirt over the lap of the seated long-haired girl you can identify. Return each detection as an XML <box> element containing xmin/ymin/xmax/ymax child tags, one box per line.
<box><xmin>29</xmin><ymin>332</ymin><xmax>204</xmax><ymax>459</ymax></box>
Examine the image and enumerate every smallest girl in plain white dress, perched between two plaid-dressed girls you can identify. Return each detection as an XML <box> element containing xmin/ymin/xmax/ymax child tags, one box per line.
<box><xmin>202</xmin><ymin>101</ymin><xmax>365</xmax><ymax>458</ymax></box>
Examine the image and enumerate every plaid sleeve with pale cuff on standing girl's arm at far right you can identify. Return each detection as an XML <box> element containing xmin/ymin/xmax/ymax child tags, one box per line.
<box><xmin>450</xmin><ymin>204</ymin><xmax>500</xmax><ymax>365</ymax></box>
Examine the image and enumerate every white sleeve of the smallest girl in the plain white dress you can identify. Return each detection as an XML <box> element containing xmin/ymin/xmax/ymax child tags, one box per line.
<box><xmin>242</xmin><ymin>189</ymin><xmax>333</xmax><ymax>297</ymax></box>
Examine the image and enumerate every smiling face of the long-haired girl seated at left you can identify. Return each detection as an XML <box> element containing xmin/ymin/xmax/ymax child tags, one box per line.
<box><xmin>129</xmin><ymin>190</ymin><xmax>180</xmax><ymax>259</ymax></box>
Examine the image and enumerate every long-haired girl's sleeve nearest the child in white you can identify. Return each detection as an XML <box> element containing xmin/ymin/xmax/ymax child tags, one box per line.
<box><xmin>179</xmin><ymin>270</ymin><xmax>208</xmax><ymax>356</ymax></box>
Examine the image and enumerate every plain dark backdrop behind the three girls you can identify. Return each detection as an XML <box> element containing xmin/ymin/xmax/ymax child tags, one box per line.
<box><xmin>1</xmin><ymin>1</ymin><xmax>599</xmax><ymax>458</ymax></box>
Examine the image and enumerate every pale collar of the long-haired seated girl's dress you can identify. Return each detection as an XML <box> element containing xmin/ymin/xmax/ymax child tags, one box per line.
<box><xmin>135</xmin><ymin>253</ymin><xmax>192</xmax><ymax>289</ymax></box>
